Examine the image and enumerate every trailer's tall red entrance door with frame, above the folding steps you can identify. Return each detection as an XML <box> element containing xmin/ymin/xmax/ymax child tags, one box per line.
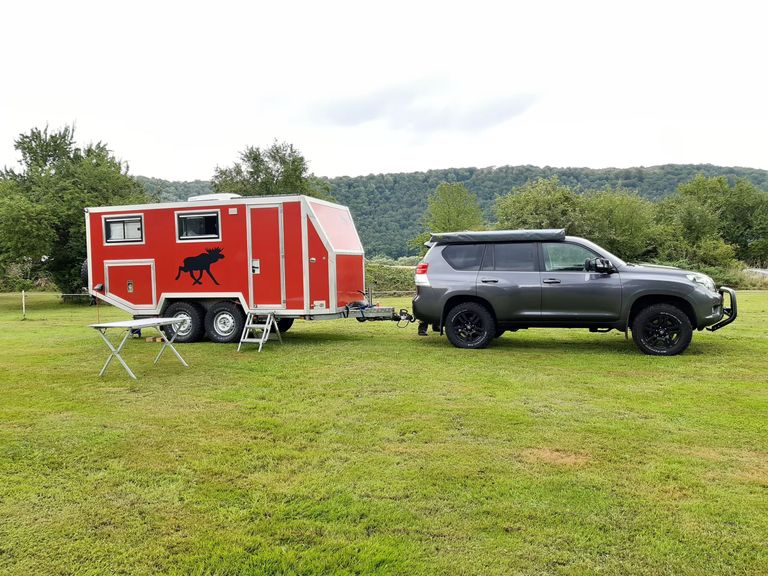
<box><xmin>249</xmin><ymin>206</ymin><xmax>285</xmax><ymax>309</ymax></box>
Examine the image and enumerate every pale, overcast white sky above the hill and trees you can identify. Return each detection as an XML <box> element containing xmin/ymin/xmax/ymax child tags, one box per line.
<box><xmin>0</xmin><ymin>0</ymin><xmax>768</xmax><ymax>180</ymax></box>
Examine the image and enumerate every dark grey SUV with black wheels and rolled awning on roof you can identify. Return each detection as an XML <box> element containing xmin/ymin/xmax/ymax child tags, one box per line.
<box><xmin>413</xmin><ymin>230</ymin><xmax>736</xmax><ymax>356</ymax></box>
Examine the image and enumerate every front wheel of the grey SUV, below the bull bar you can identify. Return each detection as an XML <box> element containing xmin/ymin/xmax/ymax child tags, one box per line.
<box><xmin>632</xmin><ymin>304</ymin><xmax>693</xmax><ymax>356</ymax></box>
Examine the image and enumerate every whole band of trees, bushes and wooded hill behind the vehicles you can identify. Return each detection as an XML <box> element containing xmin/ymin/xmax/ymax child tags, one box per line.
<box><xmin>0</xmin><ymin>127</ymin><xmax>768</xmax><ymax>293</ymax></box>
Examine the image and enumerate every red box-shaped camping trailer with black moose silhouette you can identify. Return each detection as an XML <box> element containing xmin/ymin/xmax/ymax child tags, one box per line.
<box><xmin>85</xmin><ymin>194</ymin><xmax>402</xmax><ymax>342</ymax></box>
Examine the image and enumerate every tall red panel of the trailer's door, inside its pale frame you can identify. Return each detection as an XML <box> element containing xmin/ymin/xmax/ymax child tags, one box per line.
<box><xmin>251</xmin><ymin>208</ymin><xmax>283</xmax><ymax>306</ymax></box>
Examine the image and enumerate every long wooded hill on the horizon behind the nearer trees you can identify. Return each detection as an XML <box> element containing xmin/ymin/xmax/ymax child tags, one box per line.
<box><xmin>137</xmin><ymin>164</ymin><xmax>768</xmax><ymax>258</ymax></box>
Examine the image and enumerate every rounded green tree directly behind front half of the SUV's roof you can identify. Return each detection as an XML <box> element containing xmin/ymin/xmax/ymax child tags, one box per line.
<box><xmin>494</xmin><ymin>176</ymin><xmax>584</xmax><ymax>234</ymax></box>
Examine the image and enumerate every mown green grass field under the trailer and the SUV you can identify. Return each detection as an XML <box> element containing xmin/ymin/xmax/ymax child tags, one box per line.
<box><xmin>0</xmin><ymin>292</ymin><xmax>768</xmax><ymax>575</ymax></box>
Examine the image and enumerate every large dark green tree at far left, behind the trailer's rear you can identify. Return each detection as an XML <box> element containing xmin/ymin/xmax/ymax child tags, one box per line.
<box><xmin>0</xmin><ymin>126</ymin><xmax>148</xmax><ymax>292</ymax></box>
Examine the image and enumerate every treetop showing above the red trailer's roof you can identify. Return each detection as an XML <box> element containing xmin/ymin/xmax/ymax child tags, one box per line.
<box><xmin>213</xmin><ymin>140</ymin><xmax>331</xmax><ymax>199</ymax></box>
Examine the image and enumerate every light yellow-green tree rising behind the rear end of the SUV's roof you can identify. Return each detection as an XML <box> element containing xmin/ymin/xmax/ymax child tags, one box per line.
<box><xmin>409</xmin><ymin>182</ymin><xmax>485</xmax><ymax>254</ymax></box>
